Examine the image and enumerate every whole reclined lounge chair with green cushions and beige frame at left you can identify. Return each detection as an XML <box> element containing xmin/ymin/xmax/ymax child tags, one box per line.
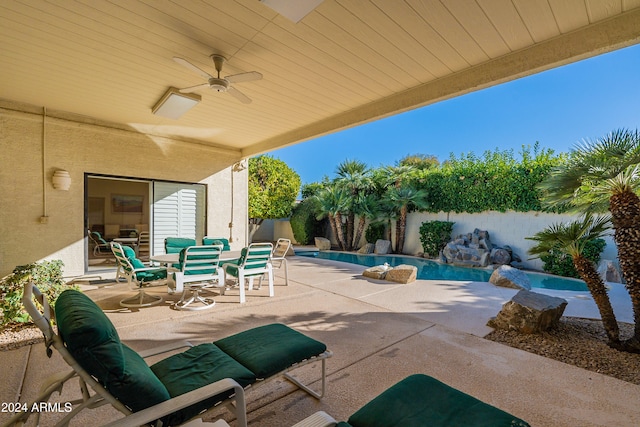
<box><xmin>6</xmin><ymin>283</ymin><xmax>331</xmax><ymax>427</ymax></box>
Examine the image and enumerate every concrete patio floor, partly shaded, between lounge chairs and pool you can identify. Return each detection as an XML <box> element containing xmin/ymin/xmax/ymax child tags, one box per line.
<box><xmin>0</xmin><ymin>256</ymin><xmax>640</xmax><ymax>427</ymax></box>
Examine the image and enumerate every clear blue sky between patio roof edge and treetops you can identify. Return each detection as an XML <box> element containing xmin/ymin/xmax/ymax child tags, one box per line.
<box><xmin>269</xmin><ymin>45</ymin><xmax>640</xmax><ymax>184</ymax></box>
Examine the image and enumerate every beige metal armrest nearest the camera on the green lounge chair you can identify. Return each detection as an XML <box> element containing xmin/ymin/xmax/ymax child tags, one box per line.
<box><xmin>103</xmin><ymin>378</ymin><xmax>247</xmax><ymax>427</ymax></box>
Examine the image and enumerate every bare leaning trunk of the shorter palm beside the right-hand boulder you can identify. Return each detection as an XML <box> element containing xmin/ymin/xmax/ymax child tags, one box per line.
<box><xmin>573</xmin><ymin>255</ymin><xmax>622</xmax><ymax>349</ymax></box>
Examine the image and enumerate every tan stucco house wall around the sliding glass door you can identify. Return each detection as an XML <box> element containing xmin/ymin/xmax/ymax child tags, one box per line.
<box><xmin>0</xmin><ymin>108</ymin><xmax>247</xmax><ymax>276</ymax></box>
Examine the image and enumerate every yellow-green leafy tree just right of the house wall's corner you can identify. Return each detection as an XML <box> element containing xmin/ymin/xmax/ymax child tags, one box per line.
<box><xmin>249</xmin><ymin>155</ymin><xmax>300</xmax><ymax>240</ymax></box>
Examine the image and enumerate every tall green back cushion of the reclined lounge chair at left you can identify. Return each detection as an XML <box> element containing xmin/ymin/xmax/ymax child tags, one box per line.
<box><xmin>55</xmin><ymin>289</ymin><xmax>170</xmax><ymax>412</ymax></box>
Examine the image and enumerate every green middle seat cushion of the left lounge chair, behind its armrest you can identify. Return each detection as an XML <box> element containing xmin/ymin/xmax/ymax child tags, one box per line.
<box><xmin>151</xmin><ymin>344</ymin><xmax>256</xmax><ymax>425</ymax></box>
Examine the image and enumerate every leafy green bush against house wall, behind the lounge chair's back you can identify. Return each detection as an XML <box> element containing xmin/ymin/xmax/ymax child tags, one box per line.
<box><xmin>0</xmin><ymin>260</ymin><xmax>75</xmax><ymax>329</ymax></box>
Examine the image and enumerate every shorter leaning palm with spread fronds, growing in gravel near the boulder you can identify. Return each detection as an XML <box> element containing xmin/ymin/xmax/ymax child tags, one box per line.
<box><xmin>529</xmin><ymin>215</ymin><xmax>622</xmax><ymax>350</ymax></box>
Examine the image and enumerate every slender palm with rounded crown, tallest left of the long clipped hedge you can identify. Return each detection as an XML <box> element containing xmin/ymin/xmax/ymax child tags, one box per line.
<box><xmin>335</xmin><ymin>160</ymin><xmax>371</xmax><ymax>250</ymax></box>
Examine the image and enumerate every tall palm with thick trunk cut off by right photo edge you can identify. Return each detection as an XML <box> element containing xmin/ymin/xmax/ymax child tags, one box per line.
<box><xmin>540</xmin><ymin>129</ymin><xmax>640</xmax><ymax>352</ymax></box>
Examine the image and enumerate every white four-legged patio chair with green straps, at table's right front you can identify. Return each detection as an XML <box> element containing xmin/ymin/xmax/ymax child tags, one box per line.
<box><xmin>222</xmin><ymin>243</ymin><xmax>274</xmax><ymax>304</ymax></box>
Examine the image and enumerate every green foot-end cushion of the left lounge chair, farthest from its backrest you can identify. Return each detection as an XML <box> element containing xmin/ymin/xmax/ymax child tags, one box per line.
<box><xmin>214</xmin><ymin>323</ymin><xmax>327</xmax><ymax>379</ymax></box>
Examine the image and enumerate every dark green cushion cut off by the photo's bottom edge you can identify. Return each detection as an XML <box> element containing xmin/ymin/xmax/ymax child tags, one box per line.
<box><xmin>348</xmin><ymin>374</ymin><xmax>528</xmax><ymax>427</ymax></box>
